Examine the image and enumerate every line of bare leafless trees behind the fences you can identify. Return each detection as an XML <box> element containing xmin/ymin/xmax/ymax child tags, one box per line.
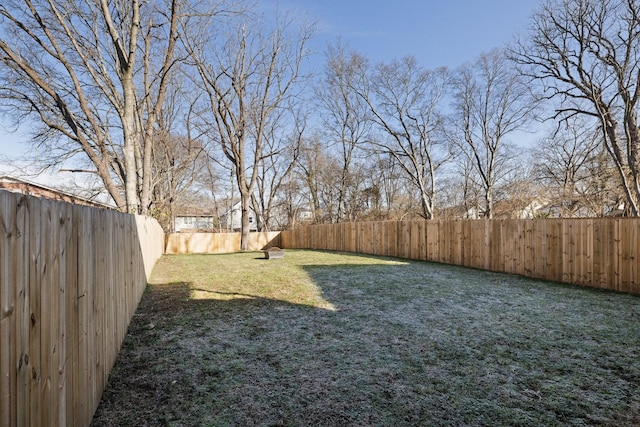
<box><xmin>0</xmin><ymin>0</ymin><xmax>640</xmax><ymax>247</ymax></box>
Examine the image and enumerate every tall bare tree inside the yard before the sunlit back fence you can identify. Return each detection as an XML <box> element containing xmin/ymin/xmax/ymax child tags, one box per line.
<box><xmin>185</xmin><ymin>10</ymin><xmax>312</xmax><ymax>250</ymax></box>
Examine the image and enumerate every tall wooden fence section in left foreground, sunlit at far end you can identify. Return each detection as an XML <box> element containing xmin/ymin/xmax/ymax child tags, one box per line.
<box><xmin>0</xmin><ymin>191</ymin><xmax>164</xmax><ymax>426</ymax></box>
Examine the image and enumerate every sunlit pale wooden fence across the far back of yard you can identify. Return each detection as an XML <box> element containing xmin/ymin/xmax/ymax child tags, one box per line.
<box><xmin>165</xmin><ymin>231</ymin><xmax>280</xmax><ymax>254</ymax></box>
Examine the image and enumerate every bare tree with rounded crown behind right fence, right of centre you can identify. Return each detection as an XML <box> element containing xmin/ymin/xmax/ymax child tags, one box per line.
<box><xmin>451</xmin><ymin>49</ymin><xmax>535</xmax><ymax>218</ymax></box>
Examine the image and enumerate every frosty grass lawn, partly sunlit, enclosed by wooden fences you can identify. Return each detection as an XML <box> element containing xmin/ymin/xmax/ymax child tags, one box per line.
<box><xmin>92</xmin><ymin>250</ymin><xmax>640</xmax><ymax>426</ymax></box>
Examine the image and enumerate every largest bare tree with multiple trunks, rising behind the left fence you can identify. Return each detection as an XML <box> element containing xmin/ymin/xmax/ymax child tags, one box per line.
<box><xmin>0</xmin><ymin>0</ymin><xmax>188</xmax><ymax>213</ymax></box>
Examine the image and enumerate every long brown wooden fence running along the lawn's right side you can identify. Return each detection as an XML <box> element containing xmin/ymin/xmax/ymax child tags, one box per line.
<box><xmin>281</xmin><ymin>218</ymin><xmax>640</xmax><ymax>294</ymax></box>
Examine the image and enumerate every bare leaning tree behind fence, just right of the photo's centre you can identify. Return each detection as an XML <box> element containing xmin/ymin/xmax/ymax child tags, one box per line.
<box><xmin>352</xmin><ymin>57</ymin><xmax>448</xmax><ymax>219</ymax></box>
